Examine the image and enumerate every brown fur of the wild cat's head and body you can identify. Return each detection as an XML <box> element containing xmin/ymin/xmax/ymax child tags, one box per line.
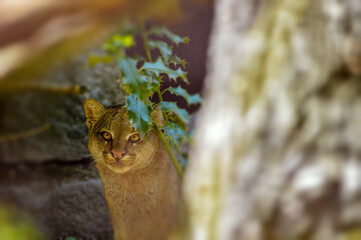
<box><xmin>84</xmin><ymin>99</ymin><xmax>180</xmax><ymax>240</ymax></box>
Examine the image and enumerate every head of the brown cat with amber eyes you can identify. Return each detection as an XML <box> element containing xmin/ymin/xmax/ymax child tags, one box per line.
<box><xmin>84</xmin><ymin>99</ymin><xmax>160</xmax><ymax>173</ymax></box>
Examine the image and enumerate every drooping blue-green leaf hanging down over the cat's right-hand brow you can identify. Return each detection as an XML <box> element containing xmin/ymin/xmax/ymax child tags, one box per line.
<box><xmin>126</xmin><ymin>94</ymin><xmax>152</xmax><ymax>137</ymax></box>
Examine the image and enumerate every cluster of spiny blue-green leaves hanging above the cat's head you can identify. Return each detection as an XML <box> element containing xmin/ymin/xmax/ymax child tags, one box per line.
<box><xmin>89</xmin><ymin>23</ymin><xmax>201</xmax><ymax>169</ymax></box>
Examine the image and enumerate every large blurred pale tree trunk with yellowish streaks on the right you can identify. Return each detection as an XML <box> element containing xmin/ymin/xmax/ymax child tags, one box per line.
<box><xmin>185</xmin><ymin>0</ymin><xmax>361</xmax><ymax>240</ymax></box>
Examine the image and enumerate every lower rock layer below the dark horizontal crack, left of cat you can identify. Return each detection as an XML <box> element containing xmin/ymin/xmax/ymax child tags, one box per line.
<box><xmin>0</xmin><ymin>160</ymin><xmax>113</xmax><ymax>239</ymax></box>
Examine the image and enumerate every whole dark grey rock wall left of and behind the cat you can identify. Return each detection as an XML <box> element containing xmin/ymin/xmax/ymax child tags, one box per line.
<box><xmin>0</xmin><ymin>50</ymin><xmax>124</xmax><ymax>239</ymax></box>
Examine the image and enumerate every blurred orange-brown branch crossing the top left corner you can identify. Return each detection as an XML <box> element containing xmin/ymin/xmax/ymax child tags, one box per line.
<box><xmin>0</xmin><ymin>0</ymin><xmax>178</xmax><ymax>80</ymax></box>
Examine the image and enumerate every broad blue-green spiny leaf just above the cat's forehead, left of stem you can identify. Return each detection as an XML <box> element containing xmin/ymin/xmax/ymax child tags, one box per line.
<box><xmin>119</xmin><ymin>58</ymin><xmax>151</xmax><ymax>100</ymax></box>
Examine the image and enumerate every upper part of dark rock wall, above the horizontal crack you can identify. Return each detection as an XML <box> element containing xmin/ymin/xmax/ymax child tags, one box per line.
<box><xmin>0</xmin><ymin>51</ymin><xmax>125</xmax><ymax>163</ymax></box>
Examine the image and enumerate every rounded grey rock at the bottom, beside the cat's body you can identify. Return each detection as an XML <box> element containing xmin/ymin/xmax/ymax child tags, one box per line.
<box><xmin>42</xmin><ymin>180</ymin><xmax>113</xmax><ymax>239</ymax></box>
